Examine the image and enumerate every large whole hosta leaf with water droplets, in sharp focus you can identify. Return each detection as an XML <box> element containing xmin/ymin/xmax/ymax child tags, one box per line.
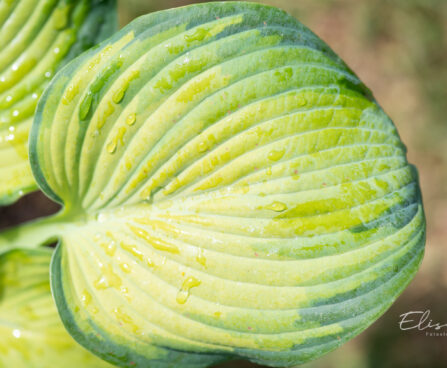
<box><xmin>31</xmin><ymin>3</ymin><xmax>425</xmax><ymax>367</ymax></box>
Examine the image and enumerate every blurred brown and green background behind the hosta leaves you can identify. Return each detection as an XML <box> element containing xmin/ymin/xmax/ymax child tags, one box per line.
<box><xmin>0</xmin><ymin>0</ymin><xmax>447</xmax><ymax>368</ymax></box>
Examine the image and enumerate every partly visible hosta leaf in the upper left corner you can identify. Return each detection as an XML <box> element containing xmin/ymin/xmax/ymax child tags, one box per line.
<box><xmin>0</xmin><ymin>0</ymin><xmax>116</xmax><ymax>205</ymax></box>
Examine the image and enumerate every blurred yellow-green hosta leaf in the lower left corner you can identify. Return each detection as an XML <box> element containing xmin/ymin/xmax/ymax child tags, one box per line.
<box><xmin>0</xmin><ymin>249</ymin><xmax>112</xmax><ymax>368</ymax></box>
